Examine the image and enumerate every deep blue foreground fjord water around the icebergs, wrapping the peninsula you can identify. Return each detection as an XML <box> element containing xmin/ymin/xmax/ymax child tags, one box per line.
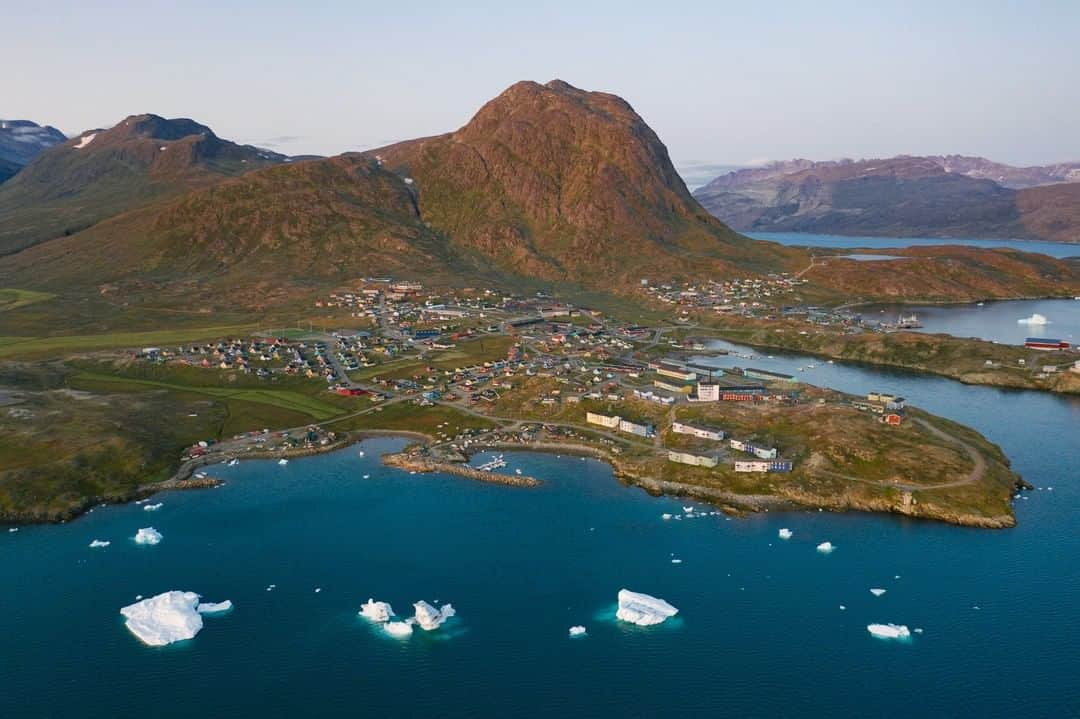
<box><xmin>0</xmin><ymin>355</ymin><xmax>1080</xmax><ymax>718</ymax></box>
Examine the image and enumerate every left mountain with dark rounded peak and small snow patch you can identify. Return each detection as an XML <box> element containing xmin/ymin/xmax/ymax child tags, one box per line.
<box><xmin>0</xmin><ymin>114</ymin><xmax>286</xmax><ymax>255</ymax></box>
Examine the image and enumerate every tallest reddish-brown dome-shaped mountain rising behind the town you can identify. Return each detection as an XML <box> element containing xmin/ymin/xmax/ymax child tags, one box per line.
<box><xmin>369</xmin><ymin>80</ymin><xmax>796</xmax><ymax>286</ymax></box>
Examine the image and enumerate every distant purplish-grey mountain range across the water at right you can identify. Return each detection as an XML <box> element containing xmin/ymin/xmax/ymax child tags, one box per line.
<box><xmin>694</xmin><ymin>155</ymin><xmax>1080</xmax><ymax>242</ymax></box>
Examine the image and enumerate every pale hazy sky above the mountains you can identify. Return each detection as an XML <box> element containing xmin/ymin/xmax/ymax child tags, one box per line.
<box><xmin>8</xmin><ymin>0</ymin><xmax>1080</xmax><ymax>165</ymax></box>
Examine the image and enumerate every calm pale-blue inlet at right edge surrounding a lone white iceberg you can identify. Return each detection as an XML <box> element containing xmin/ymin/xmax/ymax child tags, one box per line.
<box><xmin>860</xmin><ymin>299</ymin><xmax>1080</xmax><ymax>345</ymax></box>
